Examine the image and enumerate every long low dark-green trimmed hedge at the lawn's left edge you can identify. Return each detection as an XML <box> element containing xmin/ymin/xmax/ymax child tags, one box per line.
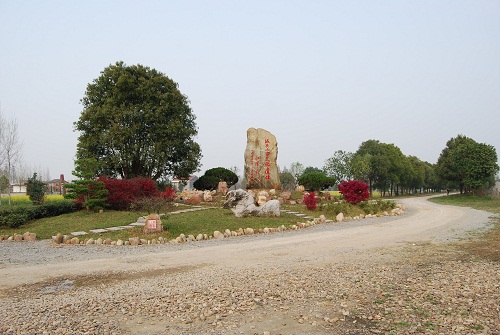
<box><xmin>0</xmin><ymin>201</ymin><xmax>78</xmax><ymax>228</ymax></box>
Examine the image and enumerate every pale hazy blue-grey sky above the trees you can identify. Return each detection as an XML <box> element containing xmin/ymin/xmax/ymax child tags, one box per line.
<box><xmin>0</xmin><ymin>0</ymin><xmax>500</xmax><ymax>184</ymax></box>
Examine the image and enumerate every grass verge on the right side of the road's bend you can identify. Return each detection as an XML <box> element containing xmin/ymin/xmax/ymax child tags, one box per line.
<box><xmin>430</xmin><ymin>194</ymin><xmax>500</xmax><ymax>262</ymax></box>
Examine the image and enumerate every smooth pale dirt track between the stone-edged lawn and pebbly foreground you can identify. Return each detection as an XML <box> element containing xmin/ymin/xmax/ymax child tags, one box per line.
<box><xmin>0</xmin><ymin>197</ymin><xmax>491</xmax><ymax>288</ymax></box>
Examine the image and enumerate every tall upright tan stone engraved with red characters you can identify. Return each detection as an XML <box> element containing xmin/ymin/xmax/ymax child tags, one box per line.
<box><xmin>245</xmin><ymin>128</ymin><xmax>281</xmax><ymax>189</ymax></box>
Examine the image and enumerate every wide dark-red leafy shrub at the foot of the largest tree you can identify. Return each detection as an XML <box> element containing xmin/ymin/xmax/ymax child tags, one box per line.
<box><xmin>98</xmin><ymin>177</ymin><xmax>159</xmax><ymax>210</ymax></box>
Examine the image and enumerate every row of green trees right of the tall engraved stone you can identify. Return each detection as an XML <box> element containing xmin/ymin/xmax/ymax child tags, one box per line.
<box><xmin>281</xmin><ymin>135</ymin><xmax>499</xmax><ymax>195</ymax></box>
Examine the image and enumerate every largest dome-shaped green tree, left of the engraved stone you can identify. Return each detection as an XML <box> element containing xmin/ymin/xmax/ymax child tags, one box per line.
<box><xmin>75</xmin><ymin>62</ymin><xmax>201</xmax><ymax>180</ymax></box>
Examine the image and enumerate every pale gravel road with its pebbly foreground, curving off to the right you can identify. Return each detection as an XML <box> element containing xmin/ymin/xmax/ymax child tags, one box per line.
<box><xmin>0</xmin><ymin>198</ymin><xmax>500</xmax><ymax>335</ymax></box>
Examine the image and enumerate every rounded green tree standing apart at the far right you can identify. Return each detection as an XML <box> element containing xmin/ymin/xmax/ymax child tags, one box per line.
<box><xmin>437</xmin><ymin>135</ymin><xmax>499</xmax><ymax>193</ymax></box>
